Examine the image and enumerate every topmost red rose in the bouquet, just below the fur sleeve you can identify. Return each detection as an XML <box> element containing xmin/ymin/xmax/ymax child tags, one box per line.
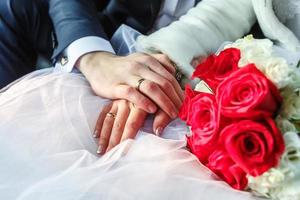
<box><xmin>192</xmin><ymin>48</ymin><xmax>241</xmax><ymax>91</ymax></box>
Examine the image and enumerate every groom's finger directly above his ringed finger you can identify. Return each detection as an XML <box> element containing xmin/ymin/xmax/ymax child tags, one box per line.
<box><xmin>138</xmin><ymin>65</ymin><xmax>182</xmax><ymax>109</ymax></box>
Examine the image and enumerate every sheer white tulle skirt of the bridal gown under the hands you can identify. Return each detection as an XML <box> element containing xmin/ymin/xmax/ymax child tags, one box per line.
<box><xmin>0</xmin><ymin>69</ymin><xmax>254</xmax><ymax>200</ymax></box>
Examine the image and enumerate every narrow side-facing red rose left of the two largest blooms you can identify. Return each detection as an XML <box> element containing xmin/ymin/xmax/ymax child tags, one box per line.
<box><xmin>187</xmin><ymin>93</ymin><xmax>220</xmax><ymax>162</ymax></box>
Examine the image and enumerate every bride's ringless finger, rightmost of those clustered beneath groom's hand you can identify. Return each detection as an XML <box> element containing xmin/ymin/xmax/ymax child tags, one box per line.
<box><xmin>121</xmin><ymin>105</ymin><xmax>147</xmax><ymax>141</ymax></box>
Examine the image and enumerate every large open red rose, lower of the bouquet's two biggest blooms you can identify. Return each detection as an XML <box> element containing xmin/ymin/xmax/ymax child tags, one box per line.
<box><xmin>220</xmin><ymin>118</ymin><xmax>284</xmax><ymax>176</ymax></box>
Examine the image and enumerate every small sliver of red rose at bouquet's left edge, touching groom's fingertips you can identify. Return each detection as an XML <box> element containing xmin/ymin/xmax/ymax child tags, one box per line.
<box><xmin>178</xmin><ymin>85</ymin><xmax>200</xmax><ymax>120</ymax></box>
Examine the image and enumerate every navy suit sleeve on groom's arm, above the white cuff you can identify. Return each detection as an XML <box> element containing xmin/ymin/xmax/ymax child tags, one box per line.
<box><xmin>48</xmin><ymin>0</ymin><xmax>107</xmax><ymax>58</ymax></box>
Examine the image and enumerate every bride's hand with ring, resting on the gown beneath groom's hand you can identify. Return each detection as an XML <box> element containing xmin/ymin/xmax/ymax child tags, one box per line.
<box><xmin>94</xmin><ymin>100</ymin><xmax>171</xmax><ymax>154</ymax></box>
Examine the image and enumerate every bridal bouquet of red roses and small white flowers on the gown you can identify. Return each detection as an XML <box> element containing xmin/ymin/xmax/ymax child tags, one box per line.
<box><xmin>179</xmin><ymin>36</ymin><xmax>300</xmax><ymax>200</ymax></box>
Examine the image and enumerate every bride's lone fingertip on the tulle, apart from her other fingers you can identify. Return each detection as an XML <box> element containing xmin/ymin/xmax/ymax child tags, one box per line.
<box><xmin>153</xmin><ymin>110</ymin><xmax>172</xmax><ymax>136</ymax></box>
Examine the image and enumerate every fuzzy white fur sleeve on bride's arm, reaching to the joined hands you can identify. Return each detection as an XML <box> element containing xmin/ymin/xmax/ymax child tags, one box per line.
<box><xmin>137</xmin><ymin>0</ymin><xmax>255</xmax><ymax>81</ymax></box>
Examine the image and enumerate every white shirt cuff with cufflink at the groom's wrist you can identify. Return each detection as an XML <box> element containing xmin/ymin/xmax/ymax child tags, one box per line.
<box><xmin>55</xmin><ymin>36</ymin><xmax>115</xmax><ymax>72</ymax></box>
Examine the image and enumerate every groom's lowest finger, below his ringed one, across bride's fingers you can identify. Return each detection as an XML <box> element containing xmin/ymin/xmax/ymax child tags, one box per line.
<box><xmin>113</xmin><ymin>83</ymin><xmax>157</xmax><ymax>113</ymax></box>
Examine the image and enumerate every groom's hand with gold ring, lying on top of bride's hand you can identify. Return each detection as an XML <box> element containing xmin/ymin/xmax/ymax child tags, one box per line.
<box><xmin>77</xmin><ymin>52</ymin><xmax>183</xmax><ymax>118</ymax></box>
